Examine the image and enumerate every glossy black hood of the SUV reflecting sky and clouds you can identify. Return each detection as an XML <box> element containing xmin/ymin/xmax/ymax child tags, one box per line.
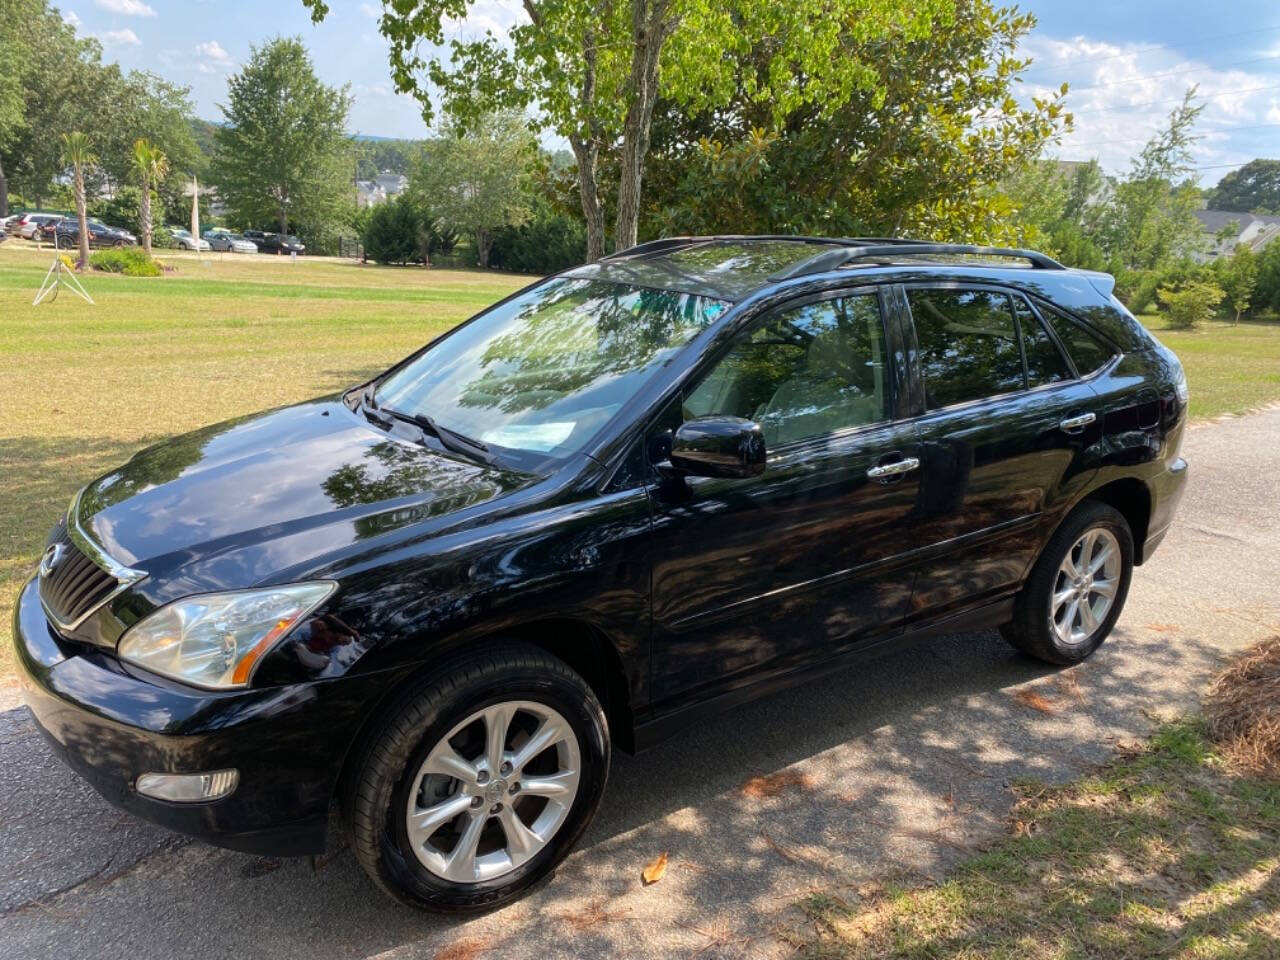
<box><xmin>77</xmin><ymin>399</ymin><xmax>538</xmax><ymax>589</ymax></box>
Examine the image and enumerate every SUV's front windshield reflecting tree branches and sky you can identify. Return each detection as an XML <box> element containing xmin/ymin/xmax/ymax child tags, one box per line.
<box><xmin>375</xmin><ymin>278</ymin><xmax>728</xmax><ymax>457</ymax></box>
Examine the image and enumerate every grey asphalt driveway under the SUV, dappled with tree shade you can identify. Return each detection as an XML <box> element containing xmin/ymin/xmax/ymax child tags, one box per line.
<box><xmin>0</xmin><ymin>410</ymin><xmax>1280</xmax><ymax>960</ymax></box>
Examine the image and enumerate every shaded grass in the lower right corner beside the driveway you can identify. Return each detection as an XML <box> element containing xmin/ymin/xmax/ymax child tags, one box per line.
<box><xmin>783</xmin><ymin>721</ymin><xmax>1280</xmax><ymax>960</ymax></box>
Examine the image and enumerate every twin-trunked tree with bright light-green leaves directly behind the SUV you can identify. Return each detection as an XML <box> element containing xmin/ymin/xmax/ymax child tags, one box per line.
<box><xmin>302</xmin><ymin>0</ymin><xmax>954</xmax><ymax>260</ymax></box>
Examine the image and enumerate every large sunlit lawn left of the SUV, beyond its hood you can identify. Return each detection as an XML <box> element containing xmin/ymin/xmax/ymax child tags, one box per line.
<box><xmin>0</xmin><ymin>241</ymin><xmax>530</xmax><ymax>682</ymax></box>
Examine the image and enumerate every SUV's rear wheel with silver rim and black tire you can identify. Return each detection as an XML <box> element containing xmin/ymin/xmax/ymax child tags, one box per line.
<box><xmin>1000</xmin><ymin>500</ymin><xmax>1133</xmax><ymax>666</ymax></box>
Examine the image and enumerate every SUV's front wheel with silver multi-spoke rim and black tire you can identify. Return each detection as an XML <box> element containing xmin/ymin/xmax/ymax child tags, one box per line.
<box><xmin>343</xmin><ymin>644</ymin><xmax>609</xmax><ymax>913</ymax></box>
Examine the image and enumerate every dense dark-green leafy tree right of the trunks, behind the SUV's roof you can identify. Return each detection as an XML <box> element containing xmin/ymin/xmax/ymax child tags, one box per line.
<box><xmin>645</xmin><ymin>0</ymin><xmax>1069</xmax><ymax>242</ymax></box>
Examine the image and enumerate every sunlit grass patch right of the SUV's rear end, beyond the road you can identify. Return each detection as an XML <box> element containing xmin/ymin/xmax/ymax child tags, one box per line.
<box><xmin>1139</xmin><ymin>315</ymin><xmax>1280</xmax><ymax>420</ymax></box>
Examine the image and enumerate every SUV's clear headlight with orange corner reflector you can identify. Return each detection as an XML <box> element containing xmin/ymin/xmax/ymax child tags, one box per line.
<box><xmin>116</xmin><ymin>580</ymin><xmax>338</xmax><ymax>689</ymax></box>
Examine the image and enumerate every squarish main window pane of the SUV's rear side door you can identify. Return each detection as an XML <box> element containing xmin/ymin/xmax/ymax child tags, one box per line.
<box><xmin>906</xmin><ymin>288</ymin><xmax>1027</xmax><ymax>410</ymax></box>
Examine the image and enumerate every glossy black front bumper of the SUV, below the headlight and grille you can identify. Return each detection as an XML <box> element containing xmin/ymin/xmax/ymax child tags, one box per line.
<box><xmin>13</xmin><ymin>580</ymin><xmax>389</xmax><ymax>856</ymax></box>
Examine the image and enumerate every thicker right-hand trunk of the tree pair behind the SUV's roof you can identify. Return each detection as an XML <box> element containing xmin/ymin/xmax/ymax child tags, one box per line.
<box><xmin>613</xmin><ymin>0</ymin><xmax>671</xmax><ymax>250</ymax></box>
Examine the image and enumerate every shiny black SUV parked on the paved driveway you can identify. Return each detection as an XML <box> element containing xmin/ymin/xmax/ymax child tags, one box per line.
<box><xmin>14</xmin><ymin>237</ymin><xmax>1187</xmax><ymax>910</ymax></box>
